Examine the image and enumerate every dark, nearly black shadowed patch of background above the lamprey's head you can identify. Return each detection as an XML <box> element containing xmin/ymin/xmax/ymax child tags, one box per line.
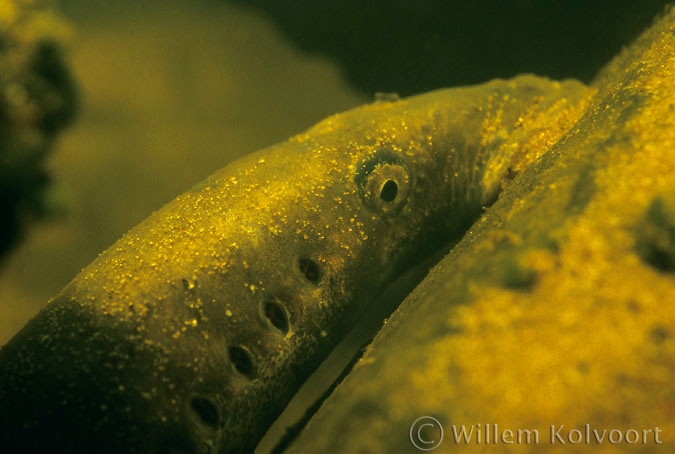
<box><xmin>232</xmin><ymin>0</ymin><xmax>667</xmax><ymax>96</ymax></box>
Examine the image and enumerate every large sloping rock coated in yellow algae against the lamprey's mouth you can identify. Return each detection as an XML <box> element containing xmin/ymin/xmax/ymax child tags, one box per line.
<box><xmin>290</xmin><ymin>4</ymin><xmax>675</xmax><ymax>453</ymax></box>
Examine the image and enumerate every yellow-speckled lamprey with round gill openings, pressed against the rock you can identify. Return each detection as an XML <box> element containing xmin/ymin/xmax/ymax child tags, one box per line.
<box><xmin>0</xmin><ymin>76</ymin><xmax>587</xmax><ymax>452</ymax></box>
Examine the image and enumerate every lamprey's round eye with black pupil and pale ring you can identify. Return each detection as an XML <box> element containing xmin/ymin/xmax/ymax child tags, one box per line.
<box><xmin>356</xmin><ymin>151</ymin><xmax>411</xmax><ymax>215</ymax></box>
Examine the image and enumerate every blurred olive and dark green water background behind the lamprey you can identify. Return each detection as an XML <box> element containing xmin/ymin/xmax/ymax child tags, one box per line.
<box><xmin>0</xmin><ymin>0</ymin><xmax>665</xmax><ymax>450</ymax></box>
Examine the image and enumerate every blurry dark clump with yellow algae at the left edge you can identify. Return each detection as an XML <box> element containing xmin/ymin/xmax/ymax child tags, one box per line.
<box><xmin>0</xmin><ymin>0</ymin><xmax>75</xmax><ymax>255</ymax></box>
